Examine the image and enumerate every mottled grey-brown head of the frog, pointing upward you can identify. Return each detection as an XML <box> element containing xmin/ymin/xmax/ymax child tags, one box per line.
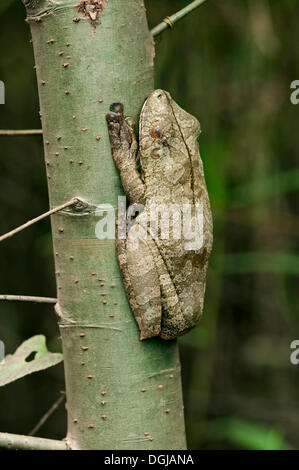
<box><xmin>139</xmin><ymin>90</ymin><xmax>200</xmax><ymax>166</ymax></box>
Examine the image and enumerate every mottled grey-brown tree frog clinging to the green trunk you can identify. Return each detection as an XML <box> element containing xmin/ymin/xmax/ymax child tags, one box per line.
<box><xmin>106</xmin><ymin>90</ymin><xmax>213</xmax><ymax>340</ymax></box>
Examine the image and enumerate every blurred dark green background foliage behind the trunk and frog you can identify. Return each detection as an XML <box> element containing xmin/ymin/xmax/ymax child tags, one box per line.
<box><xmin>0</xmin><ymin>0</ymin><xmax>299</xmax><ymax>449</ymax></box>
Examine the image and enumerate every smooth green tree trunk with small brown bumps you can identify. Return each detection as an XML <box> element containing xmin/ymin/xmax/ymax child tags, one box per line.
<box><xmin>24</xmin><ymin>0</ymin><xmax>185</xmax><ymax>450</ymax></box>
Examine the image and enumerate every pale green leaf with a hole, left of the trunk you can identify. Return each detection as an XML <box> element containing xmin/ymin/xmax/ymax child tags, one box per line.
<box><xmin>0</xmin><ymin>335</ymin><xmax>63</xmax><ymax>387</ymax></box>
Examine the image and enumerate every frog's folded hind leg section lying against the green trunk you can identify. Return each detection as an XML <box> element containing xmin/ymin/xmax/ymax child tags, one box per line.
<box><xmin>116</xmin><ymin>229</ymin><xmax>162</xmax><ymax>340</ymax></box>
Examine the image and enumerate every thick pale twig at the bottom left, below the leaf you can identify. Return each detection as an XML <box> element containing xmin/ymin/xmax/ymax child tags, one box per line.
<box><xmin>0</xmin><ymin>432</ymin><xmax>69</xmax><ymax>450</ymax></box>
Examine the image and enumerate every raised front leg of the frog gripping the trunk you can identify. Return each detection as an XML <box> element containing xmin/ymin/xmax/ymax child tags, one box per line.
<box><xmin>106</xmin><ymin>103</ymin><xmax>145</xmax><ymax>204</ymax></box>
